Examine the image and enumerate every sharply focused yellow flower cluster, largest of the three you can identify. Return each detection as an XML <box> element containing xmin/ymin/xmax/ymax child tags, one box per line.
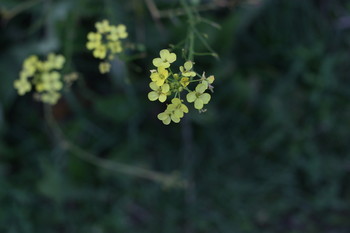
<box><xmin>148</xmin><ymin>49</ymin><xmax>215</xmax><ymax>125</ymax></box>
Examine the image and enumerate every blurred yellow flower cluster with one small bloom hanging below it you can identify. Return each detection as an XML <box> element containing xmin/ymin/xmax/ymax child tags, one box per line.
<box><xmin>86</xmin><ymin>20</ymin><xmax>128</xmax><ymax>74</ymax></box>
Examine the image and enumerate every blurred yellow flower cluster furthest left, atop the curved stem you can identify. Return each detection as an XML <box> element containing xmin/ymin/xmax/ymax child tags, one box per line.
<box><xmin>14</xmin><ymin>53</ymin><xmax>65</xmax><ymax>105</ymax></box>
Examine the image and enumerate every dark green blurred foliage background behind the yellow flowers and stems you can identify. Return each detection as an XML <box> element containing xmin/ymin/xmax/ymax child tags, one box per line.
<box><xmin>0</xmin><ymin>0</ymin><xmax>350</xmax><ymax>233</ymax></box>
